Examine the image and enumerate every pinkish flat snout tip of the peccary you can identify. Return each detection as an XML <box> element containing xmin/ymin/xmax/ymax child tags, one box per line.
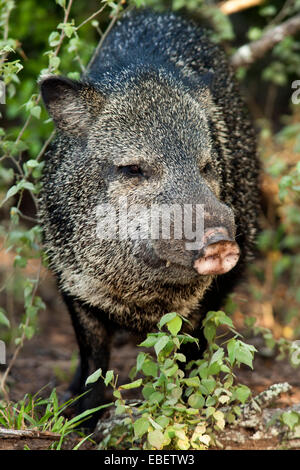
<box><xmin>194</xmin><ymin>227</ymin><xmax>240</xmax><ymax>275</ymax></box>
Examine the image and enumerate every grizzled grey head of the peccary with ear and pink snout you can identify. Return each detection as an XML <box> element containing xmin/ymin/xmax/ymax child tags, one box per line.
<box><xmin>41</xmin><ymin>72</ymin><xmax>239</xmax><ymax>312</ymax></box>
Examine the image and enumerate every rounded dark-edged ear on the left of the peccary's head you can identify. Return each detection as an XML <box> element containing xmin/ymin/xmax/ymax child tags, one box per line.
<box><xmin>39</xmin><ymin>75</ymin><xmax>104</xmax><ymax>136</ymax></box>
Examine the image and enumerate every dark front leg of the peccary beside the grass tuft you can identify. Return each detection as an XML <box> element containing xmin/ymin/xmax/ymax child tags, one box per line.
<box><xmin>64</xmin><ymin>296</ymin><xmax>112</xmax><ymax>428</ymax></box>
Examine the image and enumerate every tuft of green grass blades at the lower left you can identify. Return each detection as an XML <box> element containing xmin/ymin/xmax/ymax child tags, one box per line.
<box><xmin>0</xmin><ymin>389</ymin><xmax>110</xmax><ymax>450</ymax></box>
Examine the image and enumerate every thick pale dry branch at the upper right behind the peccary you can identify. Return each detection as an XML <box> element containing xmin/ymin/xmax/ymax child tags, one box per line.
<box><xmin>231</xmin><ymin>15</ymin><xmax>300</xmax><ymax>68</ymax></box>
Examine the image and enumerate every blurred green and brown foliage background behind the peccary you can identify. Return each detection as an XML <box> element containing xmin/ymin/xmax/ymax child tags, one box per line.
<box><xmin>0</xmin><ymin>0</ymin><xmax>300</xmax><ymax>402</ymax></box>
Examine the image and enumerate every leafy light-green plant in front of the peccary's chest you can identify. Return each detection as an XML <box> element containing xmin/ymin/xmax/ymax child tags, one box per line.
<box><xmin>87</xmin><ymin>311</ymin><xmax>255</xmax><ymax>450</ymax></box>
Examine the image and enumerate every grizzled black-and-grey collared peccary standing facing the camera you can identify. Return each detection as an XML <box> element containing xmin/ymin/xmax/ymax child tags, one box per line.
<box><xmin>39</xmin><ymin>11</ymin><xmax>259</xmax><ymax>426</ymax></box>
